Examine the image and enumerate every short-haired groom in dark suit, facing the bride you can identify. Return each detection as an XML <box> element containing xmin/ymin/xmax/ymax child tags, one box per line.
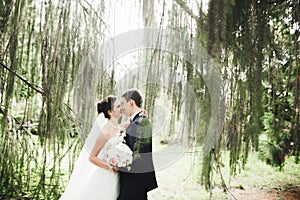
<box><xmin>117</xmin><ymin>89</ymin><xmax>157</xmax><ymax>200</ymax></box>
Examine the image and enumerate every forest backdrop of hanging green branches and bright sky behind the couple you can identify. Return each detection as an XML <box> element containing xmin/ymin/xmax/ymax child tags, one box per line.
<box><xmin>0</xmin><ymin>0</ymin><xmax>300</xmax><ymax>199</ymax></box>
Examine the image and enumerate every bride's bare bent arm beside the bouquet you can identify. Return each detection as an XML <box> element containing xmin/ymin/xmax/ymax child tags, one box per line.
<box><xmin>89</xmin><ymin>134</ymin><xmax>111</xmax><ymax>170</ymax></box>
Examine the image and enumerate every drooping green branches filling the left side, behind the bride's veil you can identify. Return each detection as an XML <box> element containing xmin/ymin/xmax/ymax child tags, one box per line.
<box><xmin>0</xmin><ymin>0</ymin><xmax>108</xmax><ymax>199</ymax></box>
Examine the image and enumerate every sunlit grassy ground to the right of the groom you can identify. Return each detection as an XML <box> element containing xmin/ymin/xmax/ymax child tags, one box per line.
<box><xmin>149</xmin><ymin>145</ymin><xmax>300</xmax><ymax>200</ymax></box>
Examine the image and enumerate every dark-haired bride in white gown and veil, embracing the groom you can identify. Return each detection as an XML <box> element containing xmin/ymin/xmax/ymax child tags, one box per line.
<box><xmin>60</xmin><ymin>96</ymin><xmax>128</xmax><ymax>200</ymax></box>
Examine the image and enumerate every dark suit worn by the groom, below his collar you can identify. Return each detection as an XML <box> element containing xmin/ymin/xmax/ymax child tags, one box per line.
<box><xmin>119</xmin><ymin>115</ymin><xmax>157</xmax><ymax>196</ymax></box>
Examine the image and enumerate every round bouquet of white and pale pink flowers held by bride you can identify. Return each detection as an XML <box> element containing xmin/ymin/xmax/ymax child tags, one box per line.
<box><xmin>104</xmin><ymin>135</ymin><xmax>133</xmax><ymax>170</ymax></box>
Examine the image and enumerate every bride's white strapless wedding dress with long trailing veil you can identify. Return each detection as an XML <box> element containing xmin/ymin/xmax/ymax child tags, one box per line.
<box><xmin>60</xmin><ymin>113</ymin><xmax>119</xmax><ymax>200</ymax></box>
